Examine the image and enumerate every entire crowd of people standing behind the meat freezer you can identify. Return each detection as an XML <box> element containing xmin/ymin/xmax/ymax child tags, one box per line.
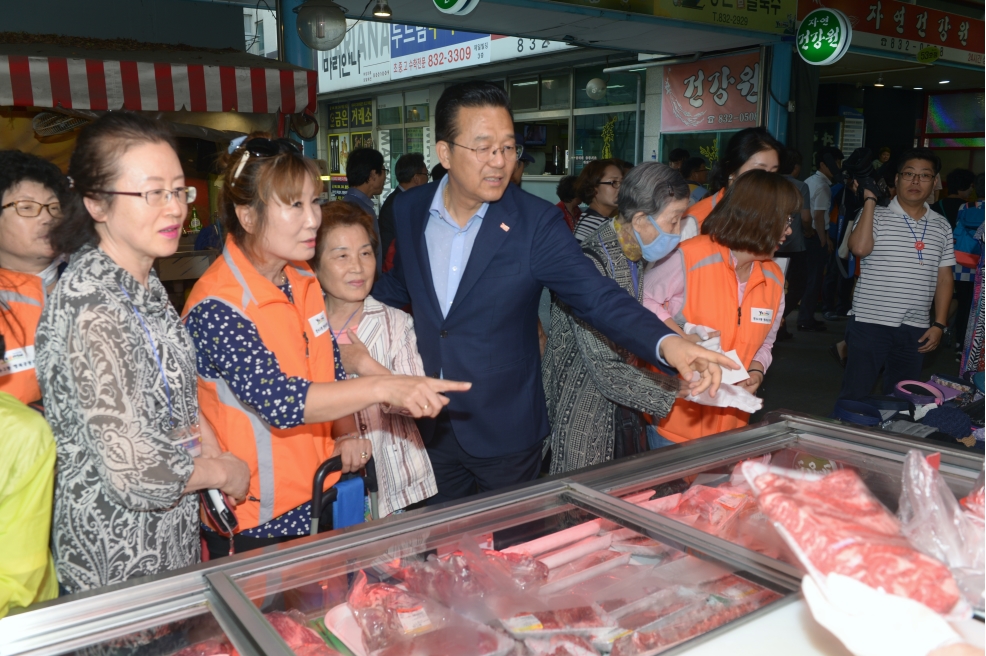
<box><xmin>0</xmin><ymin>77</ymin><xmax>982</xmax><ymax>614</ymax></box>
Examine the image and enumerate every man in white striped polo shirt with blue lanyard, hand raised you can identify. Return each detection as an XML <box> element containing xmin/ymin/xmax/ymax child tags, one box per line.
<box><xmin>839</xmin><ymin>148</ymin><xmax>955</xmax><ymax>399</ymax></box>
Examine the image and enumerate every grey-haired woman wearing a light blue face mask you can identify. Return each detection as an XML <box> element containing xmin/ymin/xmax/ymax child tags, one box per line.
<box><xmin>541</xmin><ymin>162</ymin><xmax>688</xmax><ymax>474</ymax></box>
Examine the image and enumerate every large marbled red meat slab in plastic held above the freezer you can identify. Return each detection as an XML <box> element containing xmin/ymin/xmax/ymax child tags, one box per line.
<box><xmin>744</xmin><ymin>469</ymin><xmax>960</xmax><ymax>614</ymax></box>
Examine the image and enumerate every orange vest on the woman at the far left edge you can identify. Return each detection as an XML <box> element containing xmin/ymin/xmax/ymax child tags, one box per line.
<box><xmin>0</xmin><ymin>269</ymin><xmax>45</xmax><ymax>403</ymax></box>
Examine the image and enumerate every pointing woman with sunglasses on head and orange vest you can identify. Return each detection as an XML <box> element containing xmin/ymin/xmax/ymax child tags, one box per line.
<box><xmin>184</xmin><ymin>135</ymin><xmax>469</xmax><ymax>557</ymax></box>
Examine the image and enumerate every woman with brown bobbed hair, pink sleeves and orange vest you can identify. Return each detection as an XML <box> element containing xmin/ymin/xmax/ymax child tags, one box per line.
<box><xmin>644</xmin><ymin>170</ymin><xmax>803</xmax><ymax>447</ymax></box>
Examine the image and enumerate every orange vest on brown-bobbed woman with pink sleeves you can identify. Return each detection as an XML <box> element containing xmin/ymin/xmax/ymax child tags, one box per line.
<box><xmin>658</xmin><ymin>235</ymin><xmax>784</xmax><ymax>442</ymax></box>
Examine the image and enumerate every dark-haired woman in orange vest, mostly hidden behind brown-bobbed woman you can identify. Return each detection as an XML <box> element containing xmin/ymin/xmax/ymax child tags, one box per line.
<box><xmin>681</xmin><ymin>128</ymin><xmax>784</xmax><ymax>241</ymax></box>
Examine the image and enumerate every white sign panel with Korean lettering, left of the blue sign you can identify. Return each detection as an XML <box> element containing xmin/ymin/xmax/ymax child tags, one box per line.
<box><xmin>318</xmin><ymin>20</ymin><xmax>390</xmax><ymax>93</ymax></box>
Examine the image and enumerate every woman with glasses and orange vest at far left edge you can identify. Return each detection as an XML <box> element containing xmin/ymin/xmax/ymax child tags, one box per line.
<box><xmin>0</xmin><ymin>150</ymin><xmax>68</xmax><ymax>403</ymax></box>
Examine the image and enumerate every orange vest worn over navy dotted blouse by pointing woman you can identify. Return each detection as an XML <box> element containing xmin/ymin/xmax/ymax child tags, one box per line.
<box><xmin>182</xmin><ymin>237</ymin><xmax>339</xmax><ymax>531</ymax></box>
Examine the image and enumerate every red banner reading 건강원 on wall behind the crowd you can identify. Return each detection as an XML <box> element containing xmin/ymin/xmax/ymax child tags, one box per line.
<box><xmin>661</xmin><ymin>52</ymin><xmax>761</xmax><ymax>132</ymax></box>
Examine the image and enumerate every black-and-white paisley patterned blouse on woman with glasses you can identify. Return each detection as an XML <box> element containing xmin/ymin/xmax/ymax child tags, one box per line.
<box><xmin>36</xmin><ymin>247</ymin><xmax>200</xmax><ymax>593</ymax></box>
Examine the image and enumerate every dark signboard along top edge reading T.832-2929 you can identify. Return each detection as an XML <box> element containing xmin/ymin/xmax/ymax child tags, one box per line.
<box><xmin>540</xmin><ymin>0</ymin><xmax>807</xmax><ymax>36</ymax></box>
